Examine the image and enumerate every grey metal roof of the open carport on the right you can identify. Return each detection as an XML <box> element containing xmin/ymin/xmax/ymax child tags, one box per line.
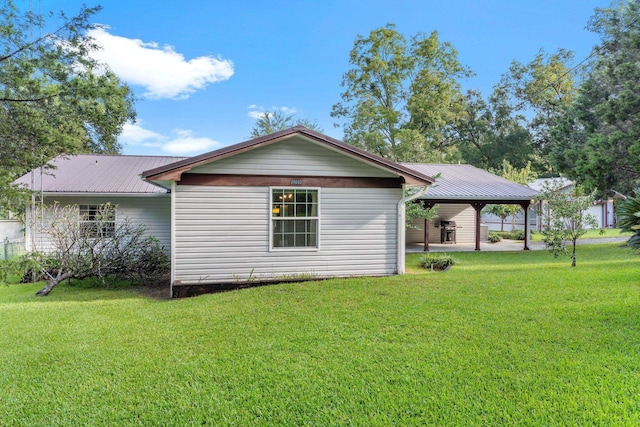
<box><xmin>403</xmin><ymin>163</ymin><xmax>538</xmax><ymax>201</ymax></box>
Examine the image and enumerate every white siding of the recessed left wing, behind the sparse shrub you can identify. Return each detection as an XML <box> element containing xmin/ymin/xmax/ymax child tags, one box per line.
<box><xmin>33</xmin><ymin>195</ymin><xmax>171</xmax><ymax>251</ymax></box>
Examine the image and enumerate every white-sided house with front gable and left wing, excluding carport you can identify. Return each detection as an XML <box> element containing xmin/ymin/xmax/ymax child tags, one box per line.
<box><xmin>17</xmin><ymin>127</ymin><xmax>433</xmax><ymax>296</ymax></box>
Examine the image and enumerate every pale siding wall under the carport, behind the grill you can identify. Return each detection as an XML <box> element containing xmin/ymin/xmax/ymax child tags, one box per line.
<box><xmin>407</xmin><ymin>204</ymin><xmax>476</xmax><ymax>244</ymax></box>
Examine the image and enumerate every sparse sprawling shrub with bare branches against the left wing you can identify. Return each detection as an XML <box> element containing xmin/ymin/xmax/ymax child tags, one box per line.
<box><xmin>29</xmin><ymin>204</ymin><xmax>170</xmax><ymax>296</ymax></box>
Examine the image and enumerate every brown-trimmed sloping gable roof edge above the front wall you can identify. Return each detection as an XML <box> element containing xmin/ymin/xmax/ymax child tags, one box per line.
<box><xmin>142</xmin><ymin>126</ymin><xmax>434</xmax><ymax>185</ymax></box>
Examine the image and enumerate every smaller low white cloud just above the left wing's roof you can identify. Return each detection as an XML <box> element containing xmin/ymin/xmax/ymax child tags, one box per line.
<box><xmin>119</xmin><ymin>123</ymin><xmax>222</xmax><ymax>155</ymax></box>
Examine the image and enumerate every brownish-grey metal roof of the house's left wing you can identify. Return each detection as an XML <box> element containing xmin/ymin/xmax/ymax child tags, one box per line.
<box><xmin>15</xmin><ymin>154</ymin><xmax>184</xmax><ymax>194</ymax></box>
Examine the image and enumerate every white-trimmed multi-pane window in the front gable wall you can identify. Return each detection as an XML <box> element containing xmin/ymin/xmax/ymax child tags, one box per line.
<box><xmin>271</xmin><ymin>188</ymin><xmax>320</xmax><ymax>249</ymax></box>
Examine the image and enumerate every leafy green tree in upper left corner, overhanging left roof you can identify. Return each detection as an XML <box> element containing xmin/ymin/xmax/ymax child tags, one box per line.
<box><xmin>0</xmin><ymin>0</ymin><xmax>135</xmax><ymax>207</ymax></box>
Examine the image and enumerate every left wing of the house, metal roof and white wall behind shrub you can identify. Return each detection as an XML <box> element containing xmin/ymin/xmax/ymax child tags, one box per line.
<box><xmin>15</xmin><ymin>154</ymin><xmax>183</xmax><ymax>251</ymax></box>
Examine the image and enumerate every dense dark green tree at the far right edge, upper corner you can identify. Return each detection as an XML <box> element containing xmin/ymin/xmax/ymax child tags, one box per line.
<box><xmin>551</xmin><ymin>1</ymin><xmax>640</xmax><ymax>195</ymax></box>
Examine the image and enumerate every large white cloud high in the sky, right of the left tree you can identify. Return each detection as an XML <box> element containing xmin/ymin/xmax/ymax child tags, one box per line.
<box><xmin>89</xmin><ymin>28</ymin><xmax>234</xmax><ymax>99</ymax></box>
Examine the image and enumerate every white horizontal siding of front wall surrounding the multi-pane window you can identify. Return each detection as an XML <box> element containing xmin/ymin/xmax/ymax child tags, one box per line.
<box><xmin>174</xmin><ymin>186</ymin><xmax>401</xmax><ymax>284</ymax></box>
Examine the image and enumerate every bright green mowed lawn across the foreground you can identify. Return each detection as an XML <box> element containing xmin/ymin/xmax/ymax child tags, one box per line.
<box><xmin>0</xmin><ymin>244</ymin><xmax>640</xmax><ymax>426</ymax></box>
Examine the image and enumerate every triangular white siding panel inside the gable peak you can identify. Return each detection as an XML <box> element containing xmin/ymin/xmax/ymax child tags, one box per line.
<box><xmin>190</xmin><ymin>137</ymin><xmax>397</xmax><ymax>177</ymax></box>
